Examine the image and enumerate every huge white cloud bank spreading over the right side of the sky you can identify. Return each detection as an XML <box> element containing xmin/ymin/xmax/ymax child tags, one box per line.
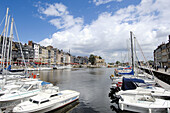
<box><xmin>37</xmin><ymin>0</ymin><xmax>170</xmax><ymax>62</ymax></box>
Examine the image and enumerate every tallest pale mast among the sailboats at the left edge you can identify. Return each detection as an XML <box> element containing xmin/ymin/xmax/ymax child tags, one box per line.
<box><xmin>1</xmin><ymin>8</ymin><xmax>9</xmax><ymax>69</ymax></box>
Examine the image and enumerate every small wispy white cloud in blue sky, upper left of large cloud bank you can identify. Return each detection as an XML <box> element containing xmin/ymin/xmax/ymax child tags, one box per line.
<box><xmin>37</xmin><ymin>3</ymin><xmax>83</xmax><ymax>29</ymax></box>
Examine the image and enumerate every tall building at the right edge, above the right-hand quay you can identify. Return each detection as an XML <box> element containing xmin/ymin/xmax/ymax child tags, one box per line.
<box><xmin>154</xmin><ymin>35</ymin><xmax>170</xmax><ymax>67</ymax></box>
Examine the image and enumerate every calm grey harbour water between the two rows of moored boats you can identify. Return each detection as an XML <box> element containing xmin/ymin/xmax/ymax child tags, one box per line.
<box><xmin>40</xmin><ymin>68</ymin><xmax>114</xmax><ymax>113</ymax></box>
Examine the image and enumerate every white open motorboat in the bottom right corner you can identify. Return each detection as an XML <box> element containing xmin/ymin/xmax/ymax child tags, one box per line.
<box><xmin>119</xmin><ymin>95</ymin><xmax>170</xmax><ymax>113</ymax></box>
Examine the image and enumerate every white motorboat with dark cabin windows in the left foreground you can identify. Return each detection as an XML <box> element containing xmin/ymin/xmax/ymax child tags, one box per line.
<box><xmin>13</xmin><ymin>86</ymin><xmax>80</xmax><ymax>113</ymax></box>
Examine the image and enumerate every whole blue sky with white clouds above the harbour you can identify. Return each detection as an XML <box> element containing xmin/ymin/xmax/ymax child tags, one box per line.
<box><xmin>0</xmin><ymin>0</ymin><xmax>170</xmax><ymax>62</ymax></box>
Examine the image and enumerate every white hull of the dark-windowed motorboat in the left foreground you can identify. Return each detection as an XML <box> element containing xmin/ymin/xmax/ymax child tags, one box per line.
<box><xmin>13</xmin><ymin>90</ymin><xmax>80</xmax><ymax>113</ymax></box>
